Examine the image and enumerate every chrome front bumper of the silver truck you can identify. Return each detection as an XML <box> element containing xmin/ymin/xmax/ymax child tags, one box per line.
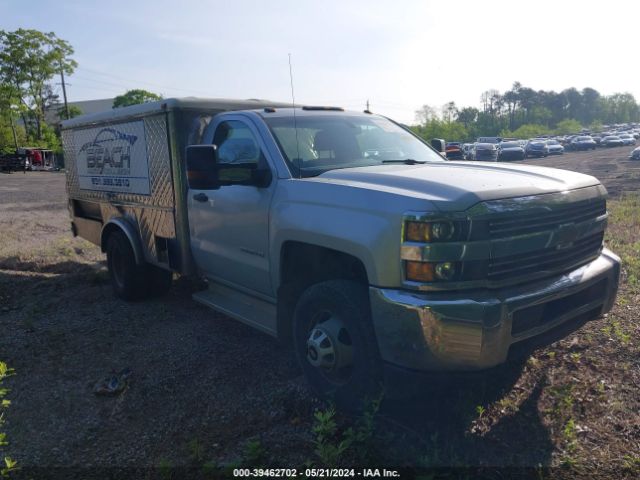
<box><xmin>369</xmin><ymin>249</ymin><xmax>620</xmax><ymax>371</ymax></box>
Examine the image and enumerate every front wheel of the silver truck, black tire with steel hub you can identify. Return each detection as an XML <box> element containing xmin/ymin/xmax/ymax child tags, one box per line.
<box><xmin>293</xmin><ymin>280</ymin><xmax>382</xmax><ymax>410</ymax></box>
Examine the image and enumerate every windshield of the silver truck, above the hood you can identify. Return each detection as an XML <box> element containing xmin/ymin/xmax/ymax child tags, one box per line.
<box><xmin>264</xmin><ymin>115</ymin><xmax>445</xmax><ymax>177</ymax></box>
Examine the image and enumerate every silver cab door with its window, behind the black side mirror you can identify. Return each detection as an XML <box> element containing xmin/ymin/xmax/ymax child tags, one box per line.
<box><xmin>188</xmin><ymin>114</ymin><xmax>276</xmax><ymax>296</ymax></box>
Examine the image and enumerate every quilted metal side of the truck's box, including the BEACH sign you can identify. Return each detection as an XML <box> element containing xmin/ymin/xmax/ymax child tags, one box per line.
<box><xmin>62</xmin><ymin>113</ymin><xmax>182</xmax><ymax>266</ymax></box>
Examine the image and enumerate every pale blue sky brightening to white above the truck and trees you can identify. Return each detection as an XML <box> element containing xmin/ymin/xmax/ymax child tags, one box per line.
<box><xmin>0</xmin><ymin>0</ymin><xmax>640</xmax><ymax>123</ymax></box>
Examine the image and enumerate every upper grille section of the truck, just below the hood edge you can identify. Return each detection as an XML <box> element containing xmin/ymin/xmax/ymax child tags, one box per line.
<box><xmin>489</xmin><ymin>199</ymin><xmax>607</xmax><ymax>238</ymax></box>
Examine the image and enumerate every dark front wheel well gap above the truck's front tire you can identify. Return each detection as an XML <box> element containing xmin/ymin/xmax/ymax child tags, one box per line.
<box><xmin>278</xmin><ymin>242</ymin><xmax>369</xmax><ymax>344</ymax></box>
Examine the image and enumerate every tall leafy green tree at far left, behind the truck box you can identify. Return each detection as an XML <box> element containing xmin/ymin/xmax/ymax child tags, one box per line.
<box><xmin>0</xmin><ymin>28</ymin><xmax>78</xmax><ymax>140</ymax></box>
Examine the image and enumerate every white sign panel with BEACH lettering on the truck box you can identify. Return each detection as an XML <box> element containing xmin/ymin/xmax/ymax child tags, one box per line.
<box><xmin>73</xmin><ymin>120</ymin><xmax>151</xmax><ymax>195</ymax></box>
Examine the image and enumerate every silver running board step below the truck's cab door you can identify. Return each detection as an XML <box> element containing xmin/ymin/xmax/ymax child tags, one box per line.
<box><xmin>192</xmin><ymin>283</ymin><xmax>277</xmax><ymax>337</ymax></box>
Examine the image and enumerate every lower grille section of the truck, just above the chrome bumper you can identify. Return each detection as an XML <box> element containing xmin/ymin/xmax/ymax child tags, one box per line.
<box><xmin>487</xmin><ymin>232</ymin><xmax>604</xmax><ymax>281</ymax></box>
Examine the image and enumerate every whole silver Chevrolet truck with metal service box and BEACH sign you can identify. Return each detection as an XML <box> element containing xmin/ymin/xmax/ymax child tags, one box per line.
<box><xmin>62</xmin><ymin>99</ymin><xmax>620</xmax><ymax>403</ymax></box>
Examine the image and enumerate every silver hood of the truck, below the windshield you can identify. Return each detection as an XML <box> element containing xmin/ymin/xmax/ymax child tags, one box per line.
<box><xmin>308</xmin><ymin>161</ymin><xmax>600</xmax><ymax>211</ymax></box>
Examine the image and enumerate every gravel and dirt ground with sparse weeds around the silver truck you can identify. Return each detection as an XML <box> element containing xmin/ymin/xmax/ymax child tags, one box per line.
<box><xmin>0</xmin><ymin>148</ymin><xmax>640</xmax><ymax>478</ymax></box>
